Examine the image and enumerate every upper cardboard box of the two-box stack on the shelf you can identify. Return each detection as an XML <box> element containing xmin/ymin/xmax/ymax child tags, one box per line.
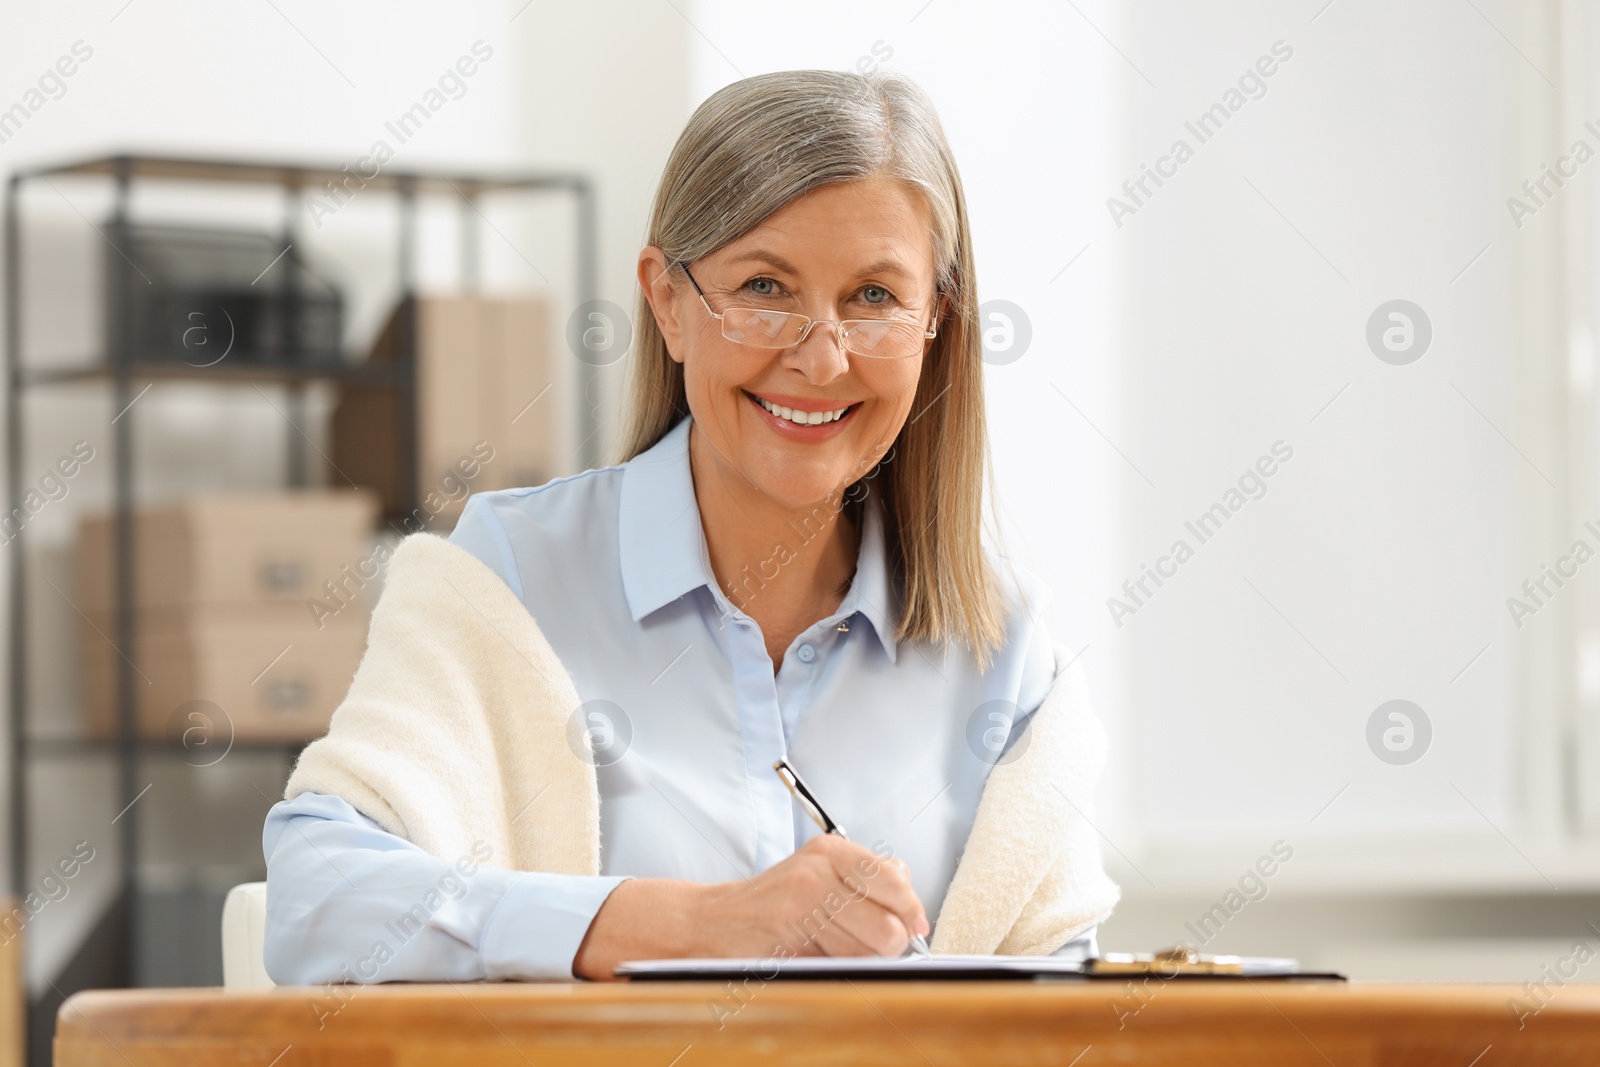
<box><xmin>77</xmin><ymin>490</ymin><xmax>378</xmax><ymax>616</ymax></box>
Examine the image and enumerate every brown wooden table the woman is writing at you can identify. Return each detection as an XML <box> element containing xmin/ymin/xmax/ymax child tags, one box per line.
<box><xmin>56</xmin><ymin>979</ymin><xmax>1600</xmax><ymax>1067</ymax></box>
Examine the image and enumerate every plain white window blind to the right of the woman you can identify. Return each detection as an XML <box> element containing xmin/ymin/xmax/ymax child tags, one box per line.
<box><xmin>1107</xmin><ymin>3</ymin><xmax>1523</xmax><ymax>846</ymax></box>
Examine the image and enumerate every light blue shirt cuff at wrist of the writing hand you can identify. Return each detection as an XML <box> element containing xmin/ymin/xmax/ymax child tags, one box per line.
<box><xmin>478</xmin><ymin>870</ymin><xmax>630</xmax><ymax>982</ymax></box>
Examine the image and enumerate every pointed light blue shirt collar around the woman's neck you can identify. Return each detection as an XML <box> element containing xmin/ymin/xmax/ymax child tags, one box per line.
<box><xmin>618</xmin><ymin>418</ymin><xmax>896</xmax><ymax>662</ymax></box>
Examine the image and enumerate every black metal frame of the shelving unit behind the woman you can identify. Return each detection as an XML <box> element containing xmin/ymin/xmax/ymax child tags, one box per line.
<box><xmin>5</xmin><ymin>155</ymin><xmax>597</xmax><ymax>1062</ymax></box>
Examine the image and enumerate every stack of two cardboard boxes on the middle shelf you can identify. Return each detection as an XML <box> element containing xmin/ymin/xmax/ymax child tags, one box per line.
<box><xmin>77</xmin><ymin>490</ymin><xmax>386</xmax><ymax>742</ymax></box>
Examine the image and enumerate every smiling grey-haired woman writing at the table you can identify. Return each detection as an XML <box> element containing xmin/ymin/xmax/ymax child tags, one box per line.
<box><xmin>262</xmin><ymin>70</ymin><xmax>1117</xmax><ymax>984</ymax></box>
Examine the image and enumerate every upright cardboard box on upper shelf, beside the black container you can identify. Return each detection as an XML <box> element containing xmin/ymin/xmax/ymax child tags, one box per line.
<box><xmin>331</xmin><ymin>296</ymin><xmax>558</xmax><ymax>533</ymax></box>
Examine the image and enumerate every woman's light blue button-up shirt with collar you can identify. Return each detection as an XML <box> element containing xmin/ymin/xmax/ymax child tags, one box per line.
<box><xmin>262</xmin><ymin>419</ymin><xmax>1094</xmax><ymax>984</ymax></box>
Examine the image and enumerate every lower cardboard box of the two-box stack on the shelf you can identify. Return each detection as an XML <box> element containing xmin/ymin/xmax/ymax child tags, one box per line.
<box><xmin>82</xmin><ymin>605</ymin><xmax>366</xmax><ymax>748</ymax></box>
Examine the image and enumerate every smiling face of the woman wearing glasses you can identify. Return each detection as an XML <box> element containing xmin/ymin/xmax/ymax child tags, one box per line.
<box><xmin>638</xmin><ymin>178</ymin><xmax>934</xmax><ymax>509</ymax></box>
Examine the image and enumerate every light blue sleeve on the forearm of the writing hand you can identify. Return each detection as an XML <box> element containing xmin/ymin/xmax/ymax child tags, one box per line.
<box><xmin>261</xmin><ymin>793</ymin><xmax>626</xmax><ymax>985</ymax></box>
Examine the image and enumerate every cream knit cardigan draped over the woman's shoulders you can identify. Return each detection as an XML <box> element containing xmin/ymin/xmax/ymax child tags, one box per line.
<box><xmin>283</xmin><ymin>534</ymin><xmax>1120</xmax><ymax>955</ymax></box>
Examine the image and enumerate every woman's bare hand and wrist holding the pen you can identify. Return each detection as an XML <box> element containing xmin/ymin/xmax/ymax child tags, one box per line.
<box><xmin>573</xmin><ymin>835</ymin><xmax>928</xmax><ymax>979</ymax></box>
